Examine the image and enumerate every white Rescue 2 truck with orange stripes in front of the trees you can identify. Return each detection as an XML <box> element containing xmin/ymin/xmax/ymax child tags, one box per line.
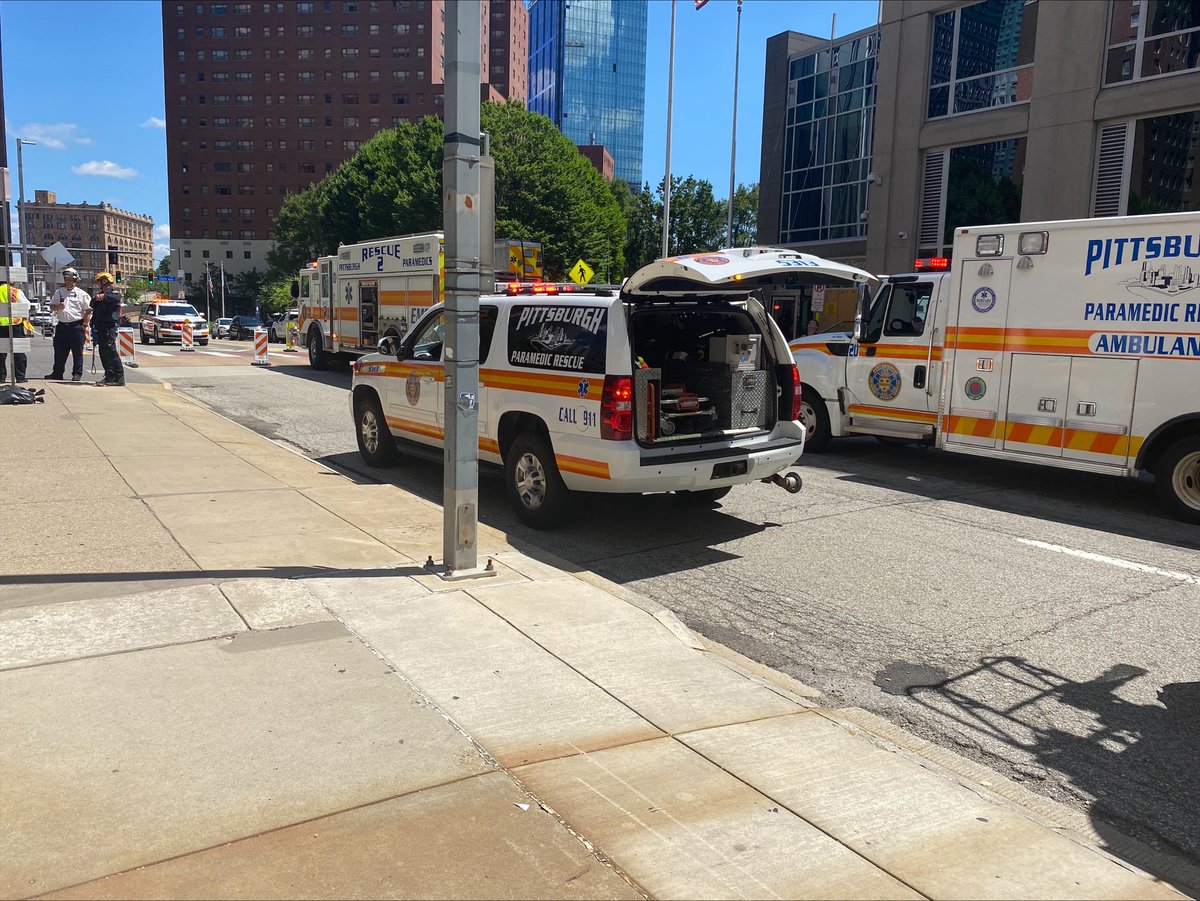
<box><xmin>293</xmin><ymin>232</ymin><xmax>445</xmax><ymax>370</ymax></box>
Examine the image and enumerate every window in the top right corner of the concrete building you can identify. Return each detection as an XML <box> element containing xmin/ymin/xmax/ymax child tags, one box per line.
<box><xmin>1104</xmin><ymin>2</ymin><xmax>1200</xmax><ymax>84</ymax></box>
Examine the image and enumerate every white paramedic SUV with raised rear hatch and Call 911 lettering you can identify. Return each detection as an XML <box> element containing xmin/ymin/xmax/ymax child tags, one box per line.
<box><xmin>350</xmin><ymin>247</ymin><xmax>870</xmax><ymax>528</ymax></box>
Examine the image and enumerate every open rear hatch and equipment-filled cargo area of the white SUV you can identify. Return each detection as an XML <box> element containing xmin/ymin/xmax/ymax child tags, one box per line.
<box><xmin>622</xmin><ymin>247</ymin><xmax>871</xmax><ymax>448</ymax></box>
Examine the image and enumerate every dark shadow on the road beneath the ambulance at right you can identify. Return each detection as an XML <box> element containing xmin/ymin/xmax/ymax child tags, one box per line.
<box><xmin>800</xmin><ymin>439</ymin><xmax>1200</xmax><ymax>551</ymax></box>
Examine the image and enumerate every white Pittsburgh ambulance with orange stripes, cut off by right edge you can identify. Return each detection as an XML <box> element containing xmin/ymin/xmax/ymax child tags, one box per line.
<box><xmin>791</xmin><ymin>212</ymin><xmax>1200</xmax><ymax>522</ymax></box>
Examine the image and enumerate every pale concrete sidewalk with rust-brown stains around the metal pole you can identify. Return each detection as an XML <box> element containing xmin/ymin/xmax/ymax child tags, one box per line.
<box><xmin>0</xmin><ymin>384</ymin><xmax>1196</xmax><ymax>899</ymax></box>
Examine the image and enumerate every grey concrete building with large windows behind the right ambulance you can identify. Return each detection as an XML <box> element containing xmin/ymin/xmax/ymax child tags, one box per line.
<box><xmin>758</xmin><ymin>0</ymin><xmax>1200</xmax><ymax>331</ymax></box>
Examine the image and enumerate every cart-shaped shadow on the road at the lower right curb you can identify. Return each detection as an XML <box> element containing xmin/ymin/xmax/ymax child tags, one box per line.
<box><xmin>876</xmin><ymin>656</ymin><xmax>1200</xmax><ymax>893</ymax></box>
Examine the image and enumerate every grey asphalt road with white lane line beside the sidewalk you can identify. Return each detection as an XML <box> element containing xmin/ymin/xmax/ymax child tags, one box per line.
<box><xmin>18</xmin><ymin>333</ymin><xmax>1200</xmax><ymax>863</ymax></box>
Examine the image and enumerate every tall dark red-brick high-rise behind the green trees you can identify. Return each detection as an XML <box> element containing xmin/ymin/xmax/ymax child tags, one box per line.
<box><xmin>162</xmin><ymin>0</ymin><xmax>529</xmax><ymax>282</ymax></box>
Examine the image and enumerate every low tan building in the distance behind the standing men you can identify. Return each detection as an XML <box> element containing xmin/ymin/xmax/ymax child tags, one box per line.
<box><xmin>25</xmin><ymin>191</ymin><xmax>155</xmax><ymax>284</ymax></box>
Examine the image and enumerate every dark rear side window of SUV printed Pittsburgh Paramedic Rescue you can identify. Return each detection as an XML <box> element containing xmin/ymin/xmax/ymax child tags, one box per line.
<box><xmin>508</xmin><ymin>304</ymin><xmax>608</xmax><ymax>373</ymax></box>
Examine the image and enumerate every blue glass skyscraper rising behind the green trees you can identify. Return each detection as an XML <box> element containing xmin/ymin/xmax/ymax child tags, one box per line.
<box><xmin>529</xmin><ymin>0</ymin><xmax>648</xmax><ymax>191</ymax></box>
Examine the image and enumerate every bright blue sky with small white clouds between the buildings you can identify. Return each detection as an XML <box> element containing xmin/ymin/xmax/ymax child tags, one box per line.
<box><xmin>0</xmin><ymin>0</ymin><xmax>878</xmax><ymax>259</ymax></box>
